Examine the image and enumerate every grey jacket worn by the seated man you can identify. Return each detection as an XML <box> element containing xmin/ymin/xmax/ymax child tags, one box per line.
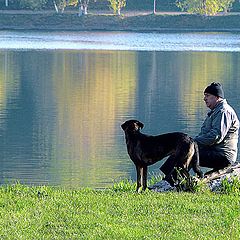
<box><xmin>195</xmin><ymin>99</ymin><xmax>239</xmax><ymax>162</ymax></box>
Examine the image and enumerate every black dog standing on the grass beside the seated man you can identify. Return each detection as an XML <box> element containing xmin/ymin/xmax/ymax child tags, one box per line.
<box><xmin>121</xmin><ymin>120</ymin><xmax>203</xmax><ymax>192</ymax></box>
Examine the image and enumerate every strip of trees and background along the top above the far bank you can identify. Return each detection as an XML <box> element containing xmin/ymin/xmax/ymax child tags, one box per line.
<box><xmin>0</xmin><ymin>0</ymin><xmax>240</xmax><ymax>15</ymax></box>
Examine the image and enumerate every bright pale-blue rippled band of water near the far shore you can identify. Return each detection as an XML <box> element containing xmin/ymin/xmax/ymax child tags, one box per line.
<box><xmin>0</xmin><ymin>31</ymin><xmax>240</xmax><ymax>52</ymax></box>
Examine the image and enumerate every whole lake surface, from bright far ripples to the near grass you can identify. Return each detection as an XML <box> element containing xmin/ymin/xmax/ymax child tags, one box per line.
<box><xmin>0</xmin><ymin>32</ymin><xmax>240</xmax><ymax>188</ymax></box>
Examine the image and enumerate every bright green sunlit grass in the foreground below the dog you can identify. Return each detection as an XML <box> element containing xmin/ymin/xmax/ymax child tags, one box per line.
<box><xmin>0</xmin><ymin>184</ymin><xmax>240</xmax><ymax>240</ymax></box>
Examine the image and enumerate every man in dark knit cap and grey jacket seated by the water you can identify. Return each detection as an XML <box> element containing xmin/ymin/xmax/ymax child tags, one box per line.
<box><xmin>195</xmin><ymin>83</ymin><xmax>239</xmax><ymax>171</ymax></box>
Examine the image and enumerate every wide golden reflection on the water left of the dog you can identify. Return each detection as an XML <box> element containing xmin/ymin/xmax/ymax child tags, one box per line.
<box><xmin>53</xmin><ymin>51</ymin><xmax>137</xmax><ymax>186</ymax></box>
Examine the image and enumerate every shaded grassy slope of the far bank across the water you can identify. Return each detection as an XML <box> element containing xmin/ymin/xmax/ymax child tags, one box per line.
<box><xmin>0</xmin><ymin>11</ymin><xmax>240</xmax><ymax>31</ymax></box>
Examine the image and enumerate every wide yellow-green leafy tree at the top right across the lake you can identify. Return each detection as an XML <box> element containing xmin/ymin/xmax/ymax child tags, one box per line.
<box><xmin>177</xmin><ymin>0</ymin><xmax>235</xmax><ymax>15</ymax></box>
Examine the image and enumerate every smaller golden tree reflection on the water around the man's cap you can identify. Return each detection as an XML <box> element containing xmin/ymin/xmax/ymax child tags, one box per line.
<box><xmin>179</xmin><ymin>52</ymin><xmax>232</xmax><ymax>127</ymax></box>
